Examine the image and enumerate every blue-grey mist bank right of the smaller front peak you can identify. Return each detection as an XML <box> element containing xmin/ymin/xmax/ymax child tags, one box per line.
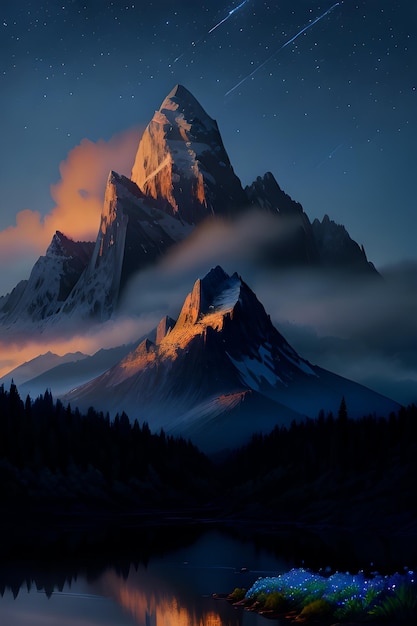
<box><xmin>258</xmin><ymin>262</ymin><xmax>417</xmax><ymax>404</ymax></box>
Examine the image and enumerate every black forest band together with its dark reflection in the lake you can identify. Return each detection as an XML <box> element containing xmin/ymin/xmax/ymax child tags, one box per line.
<box><xmin>0</xmin><ymin>386</ymin><xmax>417</xmax><ymax>566</ymax></box>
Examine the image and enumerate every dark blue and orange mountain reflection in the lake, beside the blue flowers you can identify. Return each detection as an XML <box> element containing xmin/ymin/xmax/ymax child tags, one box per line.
<box><xmin>89</xmin><ymin>531</ymin><xmax>292</xmax><ymax>626</ymax></box>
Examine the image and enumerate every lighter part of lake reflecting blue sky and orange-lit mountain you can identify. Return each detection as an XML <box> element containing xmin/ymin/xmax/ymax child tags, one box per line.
<box><xmin>0</xmin><ymin>532</ymin><xmax>290</xmax><ymax>626</ymax></box>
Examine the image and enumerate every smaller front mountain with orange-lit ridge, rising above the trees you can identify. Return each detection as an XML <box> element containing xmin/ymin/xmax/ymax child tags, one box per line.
<box><xmin>64</xmin><ymin>266</ymin><xmax>399</xmax><ymax>452</ymax></box>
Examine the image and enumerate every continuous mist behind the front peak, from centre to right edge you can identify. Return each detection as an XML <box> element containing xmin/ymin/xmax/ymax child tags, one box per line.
<box><xmin>118</xmin><ymin>213</ymin><xmax>417</xmax><ymax>404</ymax></box>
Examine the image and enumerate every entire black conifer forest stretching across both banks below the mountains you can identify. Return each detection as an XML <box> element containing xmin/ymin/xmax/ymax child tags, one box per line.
<box><xmin>0</xmin><ymin>383</ymin><xmax>417</xmax><ymax>524</ymax></box>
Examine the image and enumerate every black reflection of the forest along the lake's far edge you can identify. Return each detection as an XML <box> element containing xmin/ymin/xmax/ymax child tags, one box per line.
<box><xmin>0</xmin><ymin>506</ymin><xmax>417</xmax><ymax>573</ymax></box>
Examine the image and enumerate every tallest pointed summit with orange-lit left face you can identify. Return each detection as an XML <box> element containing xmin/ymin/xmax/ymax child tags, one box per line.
<box><xmin>131</xmin><ymin>85</ymin><xmax>247</xmax><ymax>224</ymax></box>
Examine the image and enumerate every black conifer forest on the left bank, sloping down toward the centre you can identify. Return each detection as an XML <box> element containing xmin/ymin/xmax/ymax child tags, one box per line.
<box><xmin>0</xmin><ymin>383</ymin><xmax>210</xmax><ymax>506</ymax></box>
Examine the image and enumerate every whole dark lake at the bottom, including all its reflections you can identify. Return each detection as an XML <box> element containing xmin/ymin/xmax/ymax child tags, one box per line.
<box><xmin>0</xmin><ymin>520</ymin><xmax>412</xmax><ymax>626</ymax></box>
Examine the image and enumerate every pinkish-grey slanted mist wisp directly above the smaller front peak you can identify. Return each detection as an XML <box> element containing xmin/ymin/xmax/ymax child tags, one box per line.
<box><xmin>117</xmin><ymin>211</ymin><xmax>298</xmax><ymax>317</ymax></box>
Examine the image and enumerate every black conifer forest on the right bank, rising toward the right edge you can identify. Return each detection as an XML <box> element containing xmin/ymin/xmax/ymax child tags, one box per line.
<box><xmin>218</xmin><ymin>398</ymin><xmax>417</xmax><ymax>533</ymax></box>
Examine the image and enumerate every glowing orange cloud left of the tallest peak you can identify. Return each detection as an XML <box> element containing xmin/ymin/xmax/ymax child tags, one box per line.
<box><xmin>0</xmin><ymin>128</ymin><xmax>141</xmax><ymax>294</ymax></box>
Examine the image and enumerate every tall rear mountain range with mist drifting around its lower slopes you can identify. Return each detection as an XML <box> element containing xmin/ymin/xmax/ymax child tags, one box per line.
<box><xmin>0</xmin><ymin>85</ymin><xmax>417</xmax><ymax>402</ymax></box>
